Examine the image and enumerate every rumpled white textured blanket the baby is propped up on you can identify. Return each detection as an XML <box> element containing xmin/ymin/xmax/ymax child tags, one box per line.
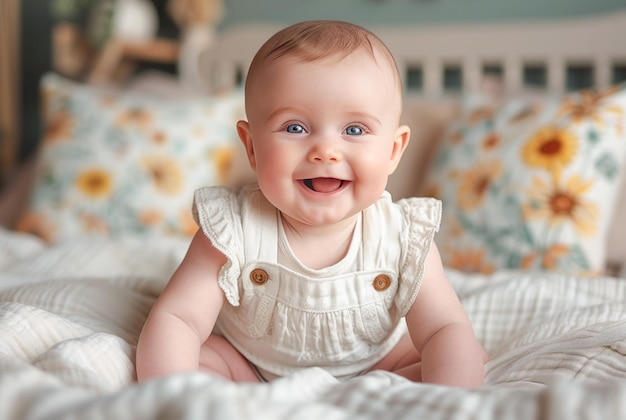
<box><xmin>0</xmin><ymin>231</ymin><xmax>626</xmax><ymax>420</ymax></box>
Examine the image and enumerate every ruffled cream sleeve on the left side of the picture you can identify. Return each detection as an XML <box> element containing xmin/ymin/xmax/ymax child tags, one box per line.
<box><xmin>193</xmin><ymin>187</ymin><xmax>244</xmax><ymax>306</ymax></box>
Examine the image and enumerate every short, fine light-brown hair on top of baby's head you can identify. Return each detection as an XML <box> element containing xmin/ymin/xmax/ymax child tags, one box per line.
<box><xmin>246</xmin><ymin>20</ymin><xmax>402</xmax><ymax>92</ymax></box>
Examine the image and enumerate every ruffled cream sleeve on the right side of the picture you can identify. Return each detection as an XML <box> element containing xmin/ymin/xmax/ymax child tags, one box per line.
<box><xmin>395</xmin><ymin>197</ymin><xmax>441</xmax><ymax>316</ymax></box>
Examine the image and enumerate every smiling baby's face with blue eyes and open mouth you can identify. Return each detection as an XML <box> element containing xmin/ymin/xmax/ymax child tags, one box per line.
<box><xmin>239</xmin><ymin>51</ymin><xmax>409</xmax><ymax>231</ymax></box>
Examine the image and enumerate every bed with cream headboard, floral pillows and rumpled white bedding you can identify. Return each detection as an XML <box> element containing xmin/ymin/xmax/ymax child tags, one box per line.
<box><xmin>0</xmin><ymin>10</ymin><xmax>626</xmax><ymax>420</ymax></box>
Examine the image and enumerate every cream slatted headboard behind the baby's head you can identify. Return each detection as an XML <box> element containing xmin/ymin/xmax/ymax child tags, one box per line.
<box><xmin>201</xmin><ymin>9</ymin><xmax>626</xmax><ymax>97</ymax></box>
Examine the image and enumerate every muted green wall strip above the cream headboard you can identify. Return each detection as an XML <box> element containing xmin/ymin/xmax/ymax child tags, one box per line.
<box><xmin>222</xmin><ymin>0</ymin><xmax>626</xmax><ymax>27</ymax></box>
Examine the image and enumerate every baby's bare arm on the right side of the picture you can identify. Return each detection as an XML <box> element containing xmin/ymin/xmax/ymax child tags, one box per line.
<box><xmin>406</xmin><ymin>243</ymin><xmax>486</xmax><ymax>387</ymax></box>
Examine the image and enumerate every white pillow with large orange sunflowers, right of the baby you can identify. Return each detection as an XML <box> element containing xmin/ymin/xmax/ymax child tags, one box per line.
<box><xmin>425</xmin><ymin>86</ymin><xmax>626</xmax><ymax>274</ymax></box>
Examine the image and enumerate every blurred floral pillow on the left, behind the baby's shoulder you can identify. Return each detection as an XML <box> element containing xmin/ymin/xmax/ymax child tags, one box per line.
<box><xmin>17</xmin><ymin>74</ymin><xmax>244</xmax><ymax>242</ymax></box>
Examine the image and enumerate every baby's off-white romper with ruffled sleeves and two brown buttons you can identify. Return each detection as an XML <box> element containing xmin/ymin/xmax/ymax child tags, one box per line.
<box><xmin>193</xmin><ymin>186</ymin><xmax>441</xmax><ymax>378</ymax></box>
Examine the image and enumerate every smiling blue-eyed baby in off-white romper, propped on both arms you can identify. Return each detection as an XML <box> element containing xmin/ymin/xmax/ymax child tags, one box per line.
<box><xmin>137</xmin><ymin>21</ymin><xmax>485</xmax><ymax>387</ymax></box>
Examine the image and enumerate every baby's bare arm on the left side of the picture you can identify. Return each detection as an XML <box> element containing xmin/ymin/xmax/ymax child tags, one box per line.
<box><xmin>136</xmin><ymin>231</ymin><xmax>226</xmax><ymax>381</ymax></box>
